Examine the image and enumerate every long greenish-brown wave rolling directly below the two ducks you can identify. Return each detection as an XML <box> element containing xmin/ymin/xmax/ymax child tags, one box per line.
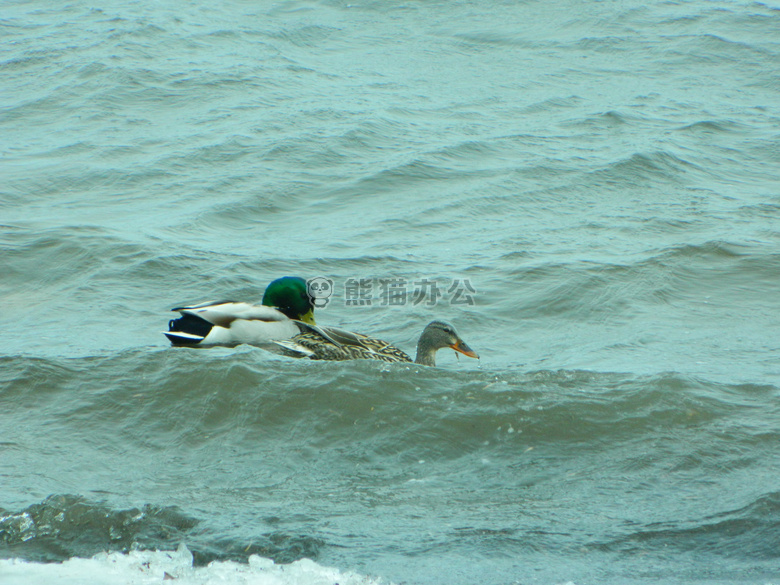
<box><xmin>0</xmin><ymin>348</ymin><xmax>778</xmax><ymax>457</ymax></box>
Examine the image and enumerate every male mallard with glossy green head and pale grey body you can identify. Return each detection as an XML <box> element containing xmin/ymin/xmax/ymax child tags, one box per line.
<box><xmin>164</xmin><ymin>276</ymin><xmax>316</xmax><ymax>346</ymax></box>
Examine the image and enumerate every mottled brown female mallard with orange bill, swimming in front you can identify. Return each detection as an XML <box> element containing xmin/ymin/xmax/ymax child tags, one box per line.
<box><xmin>275</xmin><ymin>321</ymin><xmax>479</xmax><ymax>366</ymax></box>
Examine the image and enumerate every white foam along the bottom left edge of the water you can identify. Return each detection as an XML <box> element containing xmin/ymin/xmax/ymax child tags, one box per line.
<box><xmin>0</xmin><ymin>545</ymin><xmax>385</xmax><ymax>585</ymax></box>
